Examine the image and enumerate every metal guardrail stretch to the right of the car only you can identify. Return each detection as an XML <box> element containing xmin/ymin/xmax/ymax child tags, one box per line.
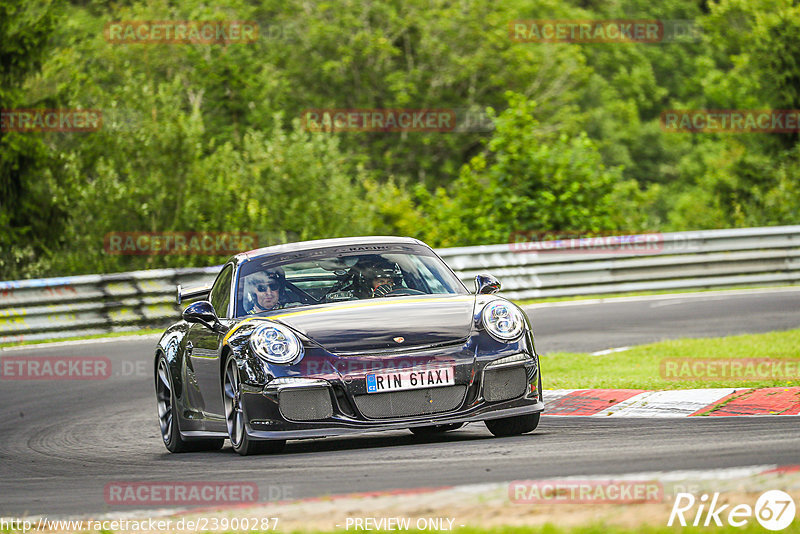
<box><xmin>438</xmin><ymin>226</ymin><xmax>800</xmax><ymax>299</ymax></box>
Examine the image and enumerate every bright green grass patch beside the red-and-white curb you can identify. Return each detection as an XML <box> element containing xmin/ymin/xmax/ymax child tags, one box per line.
<box><xmin>541</xmin><ymin>329</ymin><xmax>800</xmax><ymax>389</ymax></box>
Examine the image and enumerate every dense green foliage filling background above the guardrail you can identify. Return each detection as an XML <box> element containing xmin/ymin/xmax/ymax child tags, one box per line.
<box><xmin>0</xmin><ymin>0</ymin><xmax>800</xmax><ymax>279</ymax></box>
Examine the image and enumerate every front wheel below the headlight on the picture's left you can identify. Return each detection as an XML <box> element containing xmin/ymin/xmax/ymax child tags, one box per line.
<box><xmin>222</xmin><ymin>356</ymin><xmax>286</xmax><ymax>456</ymax></box>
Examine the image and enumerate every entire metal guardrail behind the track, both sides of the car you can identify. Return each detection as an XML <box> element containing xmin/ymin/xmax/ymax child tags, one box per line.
<box><xmin>0</xmin><ymin>226</ymin><xmax>800</xmax><ymax>343</ymax></box>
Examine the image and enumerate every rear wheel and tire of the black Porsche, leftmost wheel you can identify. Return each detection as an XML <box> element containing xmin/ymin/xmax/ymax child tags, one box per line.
<box><xmin>155</xmin><ymin>356</ymin><xmax>225</xmax><ymax>453</ymax></box>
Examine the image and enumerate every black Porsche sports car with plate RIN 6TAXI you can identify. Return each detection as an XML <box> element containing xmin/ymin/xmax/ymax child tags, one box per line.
<box><xmin>154</xmin><ymin>237</ymin><xmax>544</xmax><ymax>455</ymax></box>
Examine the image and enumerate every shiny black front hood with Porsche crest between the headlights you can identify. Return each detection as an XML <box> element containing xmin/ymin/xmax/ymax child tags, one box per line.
<box><xmin>269</xmin><ymin>295</ymin><xmax>475</xmax><ymax>353</ymax></box>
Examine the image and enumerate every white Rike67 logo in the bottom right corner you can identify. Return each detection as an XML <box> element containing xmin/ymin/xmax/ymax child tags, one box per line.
<box><xmin>667</xmin><ymin>490</ymin><xmax>796</xmax><ymax>530</ymax></box>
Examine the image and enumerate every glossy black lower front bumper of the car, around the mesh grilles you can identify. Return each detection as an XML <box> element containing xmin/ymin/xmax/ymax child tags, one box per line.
<box><xmin>242</xmin><ymin>355</ymin><xmax>544</xmax><ymax>439</ymax></box>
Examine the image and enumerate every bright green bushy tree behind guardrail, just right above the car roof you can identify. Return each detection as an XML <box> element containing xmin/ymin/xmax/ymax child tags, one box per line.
<box><xmin>412</xmin><ymin>92</ymin><xmax>643</xmax><ymax>246</ymax></box>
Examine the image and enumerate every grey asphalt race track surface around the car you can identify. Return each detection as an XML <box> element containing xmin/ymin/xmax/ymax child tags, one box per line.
<box><xmin>0</xmin><ymin>290</ymin><xmax>800</xmax><ymax>517</ymax></box>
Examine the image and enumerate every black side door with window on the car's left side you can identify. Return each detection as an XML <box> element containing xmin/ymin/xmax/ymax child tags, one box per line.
<box><xmin>186</xmin><ymin>264</ymin><xmax>233</xmax><ymax>430</ymax></box>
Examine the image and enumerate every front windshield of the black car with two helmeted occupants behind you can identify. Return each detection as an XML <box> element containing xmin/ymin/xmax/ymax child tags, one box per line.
<box><xmin>236</xmin><ymin>245</ymin><xmax>468</xmax><ymax>317</ymax></box>
